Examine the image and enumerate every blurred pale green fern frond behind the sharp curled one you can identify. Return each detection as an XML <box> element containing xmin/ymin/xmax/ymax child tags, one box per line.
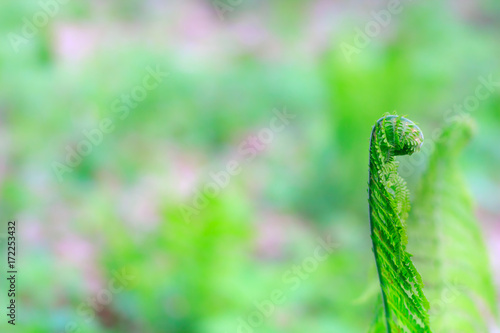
<box><xmin>410</xmin><ymin>121</ymin><xmax>497</xmax><ymax>333</ymax></box>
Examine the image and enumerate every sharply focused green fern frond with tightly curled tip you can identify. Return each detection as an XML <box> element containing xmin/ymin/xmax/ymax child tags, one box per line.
<box><xmin>368</xmin><ymin>115</ymin><xmax>431</xmax><ymax>333</ymax></box>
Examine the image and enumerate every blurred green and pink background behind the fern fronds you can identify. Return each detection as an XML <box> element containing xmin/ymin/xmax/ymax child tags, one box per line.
<box><xmin>0</xmin><ymin>0</ymin><xmax>500</xmax><ymax>333</ymax></box>
